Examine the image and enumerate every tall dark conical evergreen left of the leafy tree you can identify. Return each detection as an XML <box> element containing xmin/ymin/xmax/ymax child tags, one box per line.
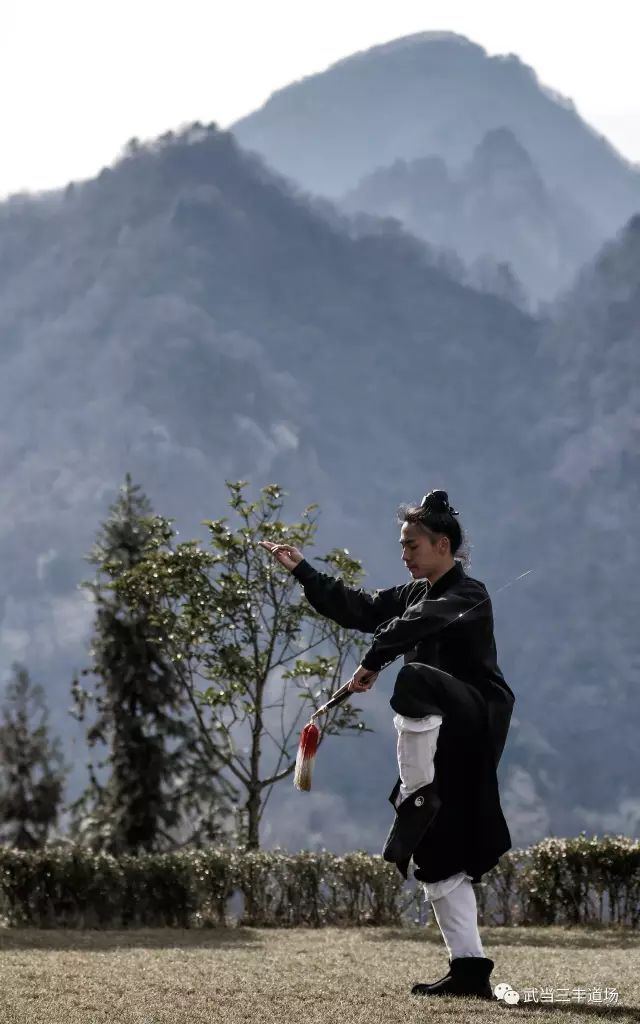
<box><xmin>72</xmin><ymin>473</ymin><xmax>232</xmax><ymax>855</ymax></box>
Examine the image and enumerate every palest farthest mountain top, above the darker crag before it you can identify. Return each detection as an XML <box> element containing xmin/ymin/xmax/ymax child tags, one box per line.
<box><xmin>231</xmin><ymin>33</ymin><xmax>640</xmax><ymax>234</ymax></box>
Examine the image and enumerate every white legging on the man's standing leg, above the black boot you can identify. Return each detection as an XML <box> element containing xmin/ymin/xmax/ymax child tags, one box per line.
<box><xmin>424</xmin><ymin>871</ymin><xmax>485</xmax><ymax>959</ymax></box>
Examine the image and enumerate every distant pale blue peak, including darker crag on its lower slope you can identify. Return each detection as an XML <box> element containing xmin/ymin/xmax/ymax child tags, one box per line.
<box><xmin>231</xmin><ymin>32</ymin><xmax>640</xmax><ymax>306</ymax></box>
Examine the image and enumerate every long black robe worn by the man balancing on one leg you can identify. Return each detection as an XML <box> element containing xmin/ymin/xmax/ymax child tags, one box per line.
<box><xmin>293</xmin><ymin>559</ymin><xmax>515</xmax><ymax>882</ymax></box>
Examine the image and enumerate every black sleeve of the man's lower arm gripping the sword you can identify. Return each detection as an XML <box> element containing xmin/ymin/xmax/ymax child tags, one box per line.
<box><xmin>360</xmin><ymin>590</ymin><xmax>483</xmax><ymax>672</ymax></box>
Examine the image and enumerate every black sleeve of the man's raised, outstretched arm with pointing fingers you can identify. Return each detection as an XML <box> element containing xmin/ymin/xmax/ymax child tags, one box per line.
<box><xmin>292</xmin><ymin>558</ymin><xmax>407</xmax><ymax>633</ymax></box>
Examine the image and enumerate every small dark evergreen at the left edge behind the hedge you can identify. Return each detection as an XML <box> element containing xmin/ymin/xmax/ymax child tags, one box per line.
<box><xmin>0</xmin><ymin>662</ymin><xmax>67</xmax><ymax>850</ymax></box>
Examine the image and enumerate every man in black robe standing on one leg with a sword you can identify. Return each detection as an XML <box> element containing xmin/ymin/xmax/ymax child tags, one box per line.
<box><xmin>260</xmin><ymin>490</ymin><xmax>515</xmax><ymax>998</ymax></box>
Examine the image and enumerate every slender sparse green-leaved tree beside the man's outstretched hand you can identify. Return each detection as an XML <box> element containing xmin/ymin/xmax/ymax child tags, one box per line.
<box><xmin>109</xmin><ymin>480</ymin><xmax>366</xmax><ymax>849</ymax></box>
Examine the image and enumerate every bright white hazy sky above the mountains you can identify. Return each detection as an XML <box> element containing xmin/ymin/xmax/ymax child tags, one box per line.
<box><xmin>0</xmin><ymin>0</ymin><xmax>640</xmax><ymax>196</ymax></box>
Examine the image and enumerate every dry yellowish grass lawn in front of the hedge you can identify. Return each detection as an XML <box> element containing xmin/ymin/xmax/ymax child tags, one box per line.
<box><xmin>0</xmin><ymin>922</ymin><xmax>640</xmax><ymax>1024</ymax></box>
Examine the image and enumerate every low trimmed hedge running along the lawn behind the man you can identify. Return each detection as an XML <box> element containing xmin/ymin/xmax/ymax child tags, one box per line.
<box><xmin>0</xmin><ymin>833</ymin><xmax>640</xmax><ymax>928</ymax></box>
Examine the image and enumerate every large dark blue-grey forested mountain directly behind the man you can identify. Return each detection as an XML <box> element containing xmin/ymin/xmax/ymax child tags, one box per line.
<box><xmin>0</xmin><ymin>114</ymin><xmax>639</xmax><ymax>849</ymax></box>
